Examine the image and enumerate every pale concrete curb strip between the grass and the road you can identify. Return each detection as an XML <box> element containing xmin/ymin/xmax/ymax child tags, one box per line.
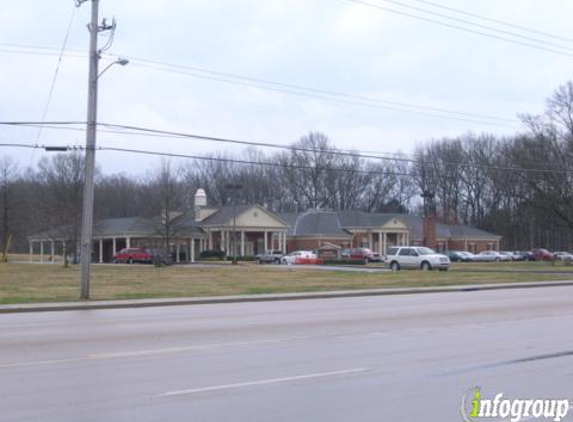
<box><xmin>0</xmin><ymin>280</ymin><xmax>573</xmax><ymax>314</ymax></box>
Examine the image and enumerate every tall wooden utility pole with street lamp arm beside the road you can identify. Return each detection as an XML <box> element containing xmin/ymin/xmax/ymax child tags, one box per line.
<box><xmin>76</xmin><ymin>0</ymin><xmax>120</xmax><ymax>299</ymax></box>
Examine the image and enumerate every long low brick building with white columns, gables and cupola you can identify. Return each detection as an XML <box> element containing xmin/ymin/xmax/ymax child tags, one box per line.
<box><xmin>28</xmin><ymin>189</ymin><xmax>501</xmax><ymax>262</ymax></box>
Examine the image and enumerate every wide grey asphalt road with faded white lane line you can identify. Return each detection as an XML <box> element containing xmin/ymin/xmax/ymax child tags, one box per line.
<box><xmin>0</xmin><ymin>287</ymin><xmax>573</xmax><ymax>422</ymax></box>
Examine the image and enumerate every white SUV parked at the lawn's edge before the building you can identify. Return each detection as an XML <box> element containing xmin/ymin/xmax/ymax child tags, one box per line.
<box><xmin>386</xmin><ymin>246</ymin><xmax>450</xmax><ymax>271</ymax></box>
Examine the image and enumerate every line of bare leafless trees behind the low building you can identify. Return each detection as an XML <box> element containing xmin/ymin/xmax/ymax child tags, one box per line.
<box><xmin>0</xmin><ymin>82</ymin><xmax>573</xmax><ymax>251</ymax></box>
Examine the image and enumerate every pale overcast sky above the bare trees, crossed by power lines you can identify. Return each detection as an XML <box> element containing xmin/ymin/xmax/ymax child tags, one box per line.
<box><xmin>0</xmin><ymin>0</ymin><xmax>573</xmax><ymax>174</ymax></box>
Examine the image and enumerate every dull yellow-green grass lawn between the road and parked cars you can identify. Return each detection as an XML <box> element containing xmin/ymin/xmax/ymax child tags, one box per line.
<box><xmin>0</xmin><ymin>263</ymin><xmax>573</xmax><ymax>304</ymax></box>
